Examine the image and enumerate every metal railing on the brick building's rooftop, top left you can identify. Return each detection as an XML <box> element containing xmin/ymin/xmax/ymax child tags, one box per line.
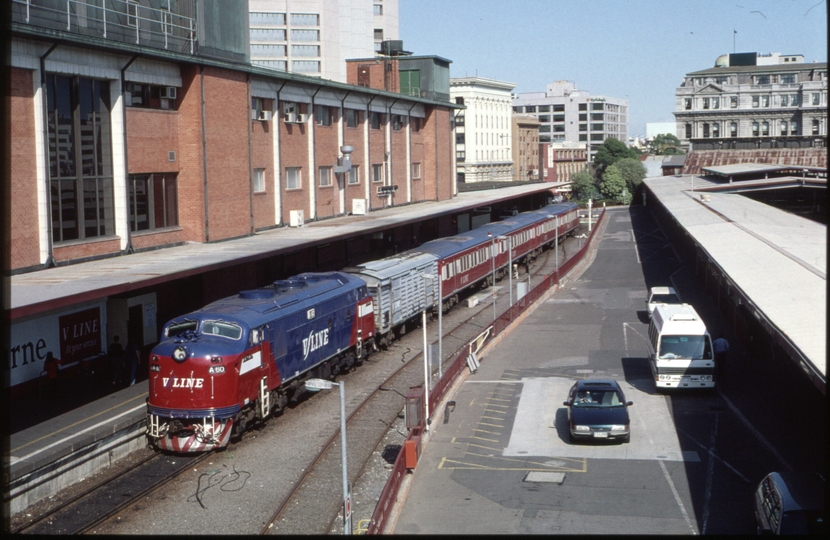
<box><xmin>12</xmin><ymin>0</ymin><xmax>197</xmax><ymax>54</ymax></box>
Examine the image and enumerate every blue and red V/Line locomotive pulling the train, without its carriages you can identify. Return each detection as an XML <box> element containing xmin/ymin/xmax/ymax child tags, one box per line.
<box><xmin>147</xmin><ymin>272</ymin><xmax>375</xmax><ymax>452</ymax></box>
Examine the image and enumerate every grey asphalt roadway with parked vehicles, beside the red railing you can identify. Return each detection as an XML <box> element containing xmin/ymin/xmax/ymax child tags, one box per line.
<box><xmin>393</xmin><ymin>207</ymin><xmax>826</xmax><ymax>534</ymax></box>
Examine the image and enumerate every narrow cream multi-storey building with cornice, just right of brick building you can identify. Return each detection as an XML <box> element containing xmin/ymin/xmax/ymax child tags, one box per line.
<box><xmin>450</xmin><ymin>77</ymin><xmax>516</xmax><ymax>182</ymax></box>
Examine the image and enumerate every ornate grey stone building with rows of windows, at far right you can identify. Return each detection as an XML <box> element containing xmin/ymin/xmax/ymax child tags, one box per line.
<box><xmin>674</xmin><ymin>53</ymin><xmax>827</xmax><ymax>150</ymax></box>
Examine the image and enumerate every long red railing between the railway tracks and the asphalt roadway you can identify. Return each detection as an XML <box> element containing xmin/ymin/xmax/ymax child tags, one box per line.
<box><xmin>366</xmin><ymin>210</ymin><xmax>605</xmax><ymax>534</ymax></box>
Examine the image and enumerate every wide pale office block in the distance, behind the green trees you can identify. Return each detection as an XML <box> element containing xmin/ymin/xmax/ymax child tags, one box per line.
<box><xmin>513</xmin><ymin>81</ymin><xmax>628</xmax><ymax>161</ymax></box>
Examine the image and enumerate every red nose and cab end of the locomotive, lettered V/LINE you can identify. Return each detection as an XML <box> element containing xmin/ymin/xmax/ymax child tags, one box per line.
<box><xmin>147</xmin><ymin>315</ymin><xmax>272</xmax><ymax>452</ymax></box>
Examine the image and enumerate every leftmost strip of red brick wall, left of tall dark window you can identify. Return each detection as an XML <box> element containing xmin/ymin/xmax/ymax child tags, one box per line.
<box><xmin>9</xmin><ymin>68</ymin><xmax>40</xmax><ymax>269</ymax></box>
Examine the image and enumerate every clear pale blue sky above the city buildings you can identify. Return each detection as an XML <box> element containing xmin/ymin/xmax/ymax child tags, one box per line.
<box><xmin>398</xmin><ymin>0</ymin><xmax>827</xmax><ymax>136</ymax></box>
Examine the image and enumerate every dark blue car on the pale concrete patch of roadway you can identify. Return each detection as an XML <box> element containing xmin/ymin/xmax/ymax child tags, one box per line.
<box><xmin>563</xmin><ymin>379</ymin><xmax>634</xmax><ymax>442</ymax></box>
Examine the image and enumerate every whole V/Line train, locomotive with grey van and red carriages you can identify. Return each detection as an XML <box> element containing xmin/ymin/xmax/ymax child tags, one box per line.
<box><xmin>147</xmin><ymin>203</ymin><xmax>579</xmax><ymax>452</ymax></box>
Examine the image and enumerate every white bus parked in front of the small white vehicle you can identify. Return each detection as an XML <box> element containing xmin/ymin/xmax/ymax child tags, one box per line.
<box><xmin>648</xmin><ymin>304</ymin><xmax>715</xmax><ymax>390</ymax></box>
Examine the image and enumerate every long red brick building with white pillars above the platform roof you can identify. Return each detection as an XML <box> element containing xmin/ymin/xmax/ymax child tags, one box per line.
<box><xmin>7</xmin><ymin>0</ymin><xmax>455</xmax><ymax>273</ymax></box>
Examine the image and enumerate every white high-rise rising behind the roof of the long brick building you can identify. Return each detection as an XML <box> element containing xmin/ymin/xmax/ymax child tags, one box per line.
<box><xmin>248</xmin><ymin>0</ymin><xmax>399</xmax><ymax>82</ymax></box>
